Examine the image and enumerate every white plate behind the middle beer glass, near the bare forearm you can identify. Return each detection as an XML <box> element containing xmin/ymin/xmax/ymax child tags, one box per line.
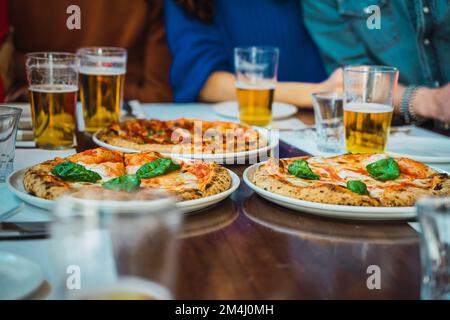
<box><xmin>213</xmin><ymin>101</ymin><xmax>297</xmax><ymax>120</ymax></box>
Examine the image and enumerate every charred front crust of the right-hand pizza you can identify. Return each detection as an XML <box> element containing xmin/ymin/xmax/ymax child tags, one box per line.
<box><xmin>252</xmin><ymin>155</ymin><xmax>450</xmax><ymax>207</ymax></box>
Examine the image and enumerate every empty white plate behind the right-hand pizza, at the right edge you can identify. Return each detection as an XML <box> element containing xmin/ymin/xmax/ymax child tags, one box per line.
<box><xmin>386</xmin><ymin>136</ymin><xmax>450</xmax><ymax>163</ymax></box>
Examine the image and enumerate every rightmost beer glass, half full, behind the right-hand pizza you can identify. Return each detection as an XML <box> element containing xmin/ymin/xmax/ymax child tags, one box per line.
<box><xmin>344</xmin><ymin>65</ymin><xmax>398</xmax><ymax>153</ymax></box>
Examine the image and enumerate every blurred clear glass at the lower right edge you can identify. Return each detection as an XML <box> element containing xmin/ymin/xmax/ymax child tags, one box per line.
<box><xmin>416</xmin><ymin>198</ymin><xmax>450</xmax><ymax>300</ymax></box>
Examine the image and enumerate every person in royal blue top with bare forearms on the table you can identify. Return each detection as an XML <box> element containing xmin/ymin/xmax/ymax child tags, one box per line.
<box><xmin>165</xmin><ymin>0</ymin><xmax>342</xmax><ymax>107</ymax></box>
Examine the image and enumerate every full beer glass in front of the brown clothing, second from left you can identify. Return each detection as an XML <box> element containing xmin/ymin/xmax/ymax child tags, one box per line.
<box><xmin>77</xmin><ymin>47</ymin><xmax>127</xmax><ymax>133</ymax></box>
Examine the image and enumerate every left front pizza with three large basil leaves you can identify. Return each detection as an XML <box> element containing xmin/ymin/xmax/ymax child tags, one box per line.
<box><xmin>23</xmin><ymin>148</ymin><xmax>231</xmax><ymax>201</ymax></box>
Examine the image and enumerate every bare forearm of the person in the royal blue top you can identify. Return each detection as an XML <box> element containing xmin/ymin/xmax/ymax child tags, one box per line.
<box><xmin>199</xmin><ymin>69</ymin><xmax>342</xmax><ymax>107</ymax></box>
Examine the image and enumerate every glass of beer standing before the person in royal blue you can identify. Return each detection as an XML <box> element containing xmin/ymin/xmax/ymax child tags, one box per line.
<box><xmin>234</xmin><ymin>47</ymin><xmax>280</xmax><ymax>127</ymax></box>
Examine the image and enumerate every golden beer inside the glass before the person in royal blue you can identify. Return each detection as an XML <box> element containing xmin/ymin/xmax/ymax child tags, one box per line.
<box><xmin>237</xmin><ymin>85</ymin><xmax>275</xmax><ymax>127</ymax></box>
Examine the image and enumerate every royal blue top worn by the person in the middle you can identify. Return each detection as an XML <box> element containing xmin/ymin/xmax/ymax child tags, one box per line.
<box><xmin>165</xmin><ymin>0</ymin><xmax>326</xmax><ymax>102</ymax></box>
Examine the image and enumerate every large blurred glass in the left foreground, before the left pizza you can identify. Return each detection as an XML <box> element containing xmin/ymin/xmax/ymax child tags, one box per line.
<box><xmin>51</xmin><ymin>190</ymin><xmax>182</xmax><ymax>300</ymax></box>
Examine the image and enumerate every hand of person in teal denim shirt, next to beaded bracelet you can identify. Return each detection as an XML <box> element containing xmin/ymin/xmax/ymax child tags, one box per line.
<box><xmin>413</xmin><ymin>83</ymin><xmax>450</xmax><ymax>123</ymax></box>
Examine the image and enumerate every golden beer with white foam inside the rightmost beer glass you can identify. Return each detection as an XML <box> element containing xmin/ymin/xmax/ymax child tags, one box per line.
<box><xmin>344</xmin><ymin>103</ymin><xmax>393</xmax><ymax>153</ymax></box>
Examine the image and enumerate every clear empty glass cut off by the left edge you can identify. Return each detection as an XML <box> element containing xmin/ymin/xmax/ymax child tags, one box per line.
<box><xmin>0</xmin><ymin>106</ymin><xmax>22</xmax><ymax>183</ymax></box>
